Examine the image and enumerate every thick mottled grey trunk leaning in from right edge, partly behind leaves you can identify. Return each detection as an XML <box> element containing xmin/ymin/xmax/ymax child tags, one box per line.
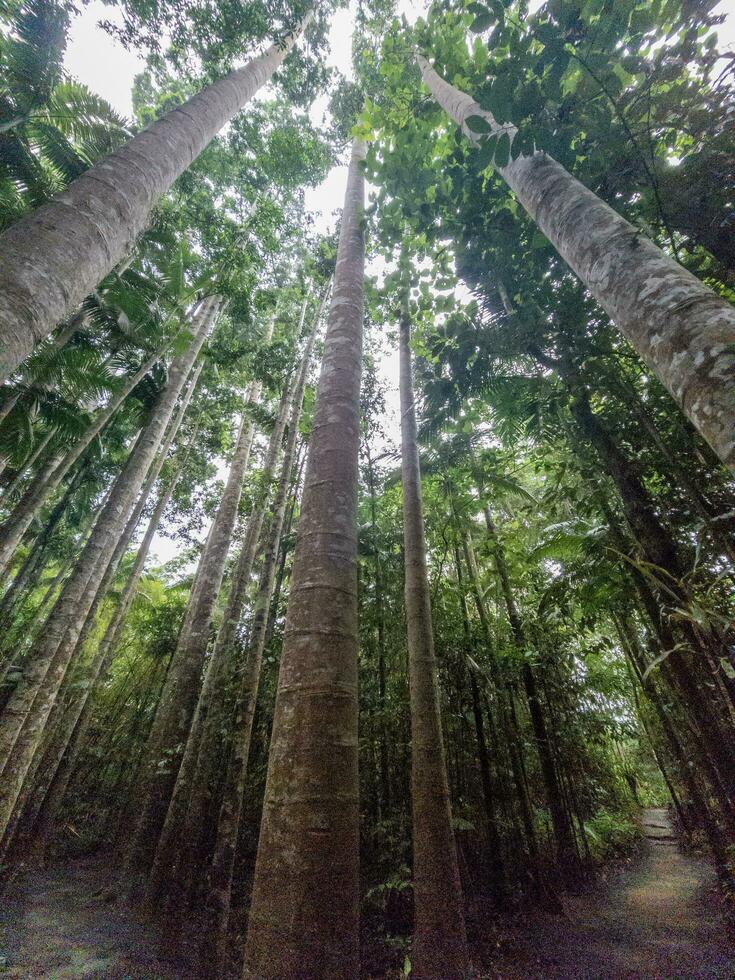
<box><xmin>418</xmin><ymin>55</ymin><xmax>735</xmax><ymax>467</ymax></box>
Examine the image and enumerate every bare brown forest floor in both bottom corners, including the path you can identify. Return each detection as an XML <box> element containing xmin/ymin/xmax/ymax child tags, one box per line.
<box><xmin>0</xmin><ymin>810</ymin><xmax>735</xmax><ymax>980</ymax></box>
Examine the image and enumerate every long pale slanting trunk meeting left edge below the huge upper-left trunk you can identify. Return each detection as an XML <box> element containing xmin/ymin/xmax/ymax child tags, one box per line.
<box><xmin>0</xmin><ymin>300</ymin><xmax>219</xmax><ymax>832</ymax></box>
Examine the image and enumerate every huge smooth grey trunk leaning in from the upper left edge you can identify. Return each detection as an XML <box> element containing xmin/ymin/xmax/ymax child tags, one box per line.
<box><xmin>0</xmin><ymin>25</ymin><xmax>303</xmax><ymax>380</ymax></box>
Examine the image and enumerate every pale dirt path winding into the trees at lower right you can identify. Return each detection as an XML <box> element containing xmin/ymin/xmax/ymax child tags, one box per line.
<box><xmin>486</xmin><ymin>809</ymin><xmax>735</xmax><ymax>980</ymax></box>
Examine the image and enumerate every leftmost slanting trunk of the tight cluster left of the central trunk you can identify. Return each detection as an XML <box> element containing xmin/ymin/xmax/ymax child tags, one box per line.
<box><xmin>127</xmin><ymin>350</ymin><xmax>272</xmax><ymax>874</ymax></box>
